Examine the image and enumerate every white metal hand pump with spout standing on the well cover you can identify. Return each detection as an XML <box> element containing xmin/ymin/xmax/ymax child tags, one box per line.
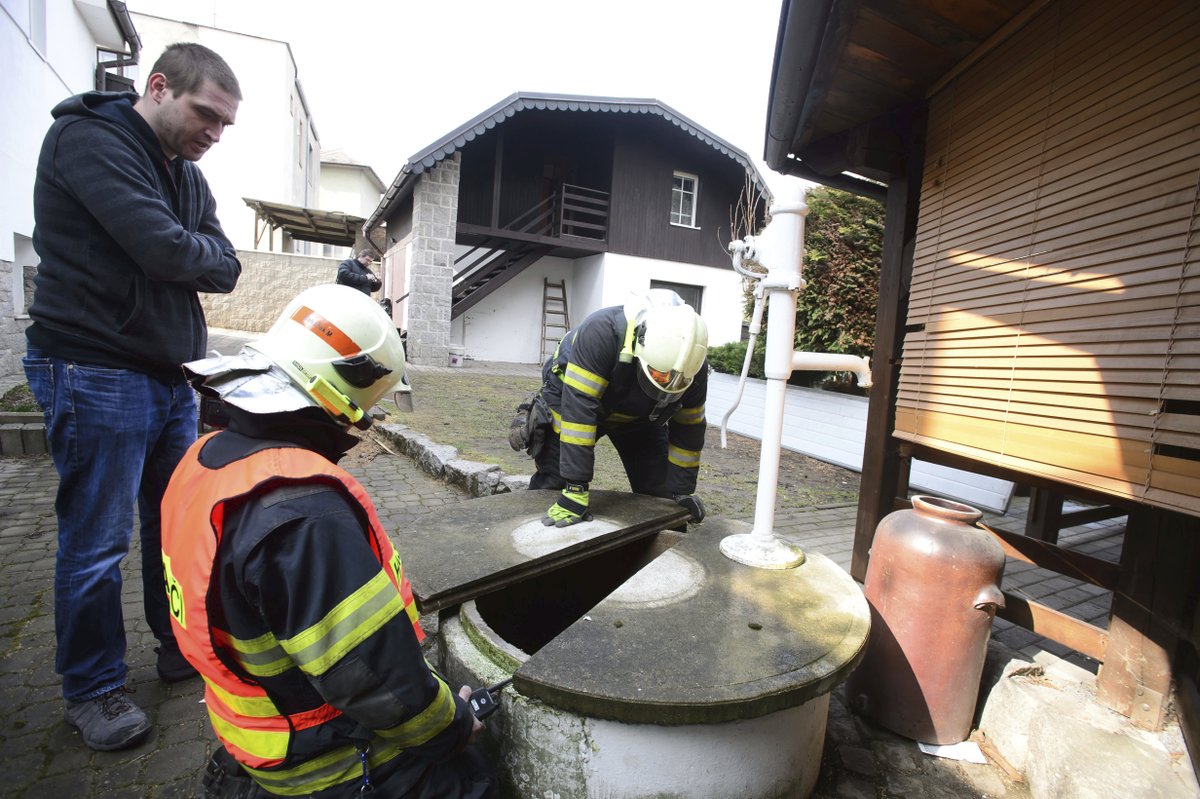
<box><xmin>720</xmin><ymin>187</ymin><xmax>870</xmax><ymax>569</ymax></box>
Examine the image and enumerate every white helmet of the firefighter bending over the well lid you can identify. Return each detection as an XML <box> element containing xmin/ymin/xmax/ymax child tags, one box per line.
<box><xmin>634</xmin><ymin>305</ymin><xmax>708</xmax><ymax>400</ymax></box>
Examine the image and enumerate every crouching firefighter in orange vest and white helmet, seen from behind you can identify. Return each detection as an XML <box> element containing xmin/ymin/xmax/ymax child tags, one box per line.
<box><xmin>162</xmin><ymin>286</ymin><xmax>497</xmax><ymax>798</ymax></box>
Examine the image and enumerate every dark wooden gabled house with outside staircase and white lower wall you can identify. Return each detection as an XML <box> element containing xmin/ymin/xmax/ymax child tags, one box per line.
<box><xmin>366</xmin><ymin>94</ymin><xmax>767</xmax><ymax>364</ymax></box>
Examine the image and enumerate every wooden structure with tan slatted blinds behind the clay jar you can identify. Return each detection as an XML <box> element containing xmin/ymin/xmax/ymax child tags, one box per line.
<box><xmin>766</xmin><ymin>0</ymin><xmax>1200</xmax><ymax>772</ymax></box>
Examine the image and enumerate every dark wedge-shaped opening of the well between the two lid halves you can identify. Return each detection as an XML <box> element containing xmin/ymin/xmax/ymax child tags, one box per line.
<box><xmin>475</xmin><ymin>530</ymin><xmax>683</xmax><ymax>655</ymax></box>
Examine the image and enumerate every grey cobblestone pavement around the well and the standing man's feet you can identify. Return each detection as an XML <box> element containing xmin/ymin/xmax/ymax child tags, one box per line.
<box><xmin>0</xmin><ymin>347</ymin><xmax>1120</xmax><ymax>799</ymax></box>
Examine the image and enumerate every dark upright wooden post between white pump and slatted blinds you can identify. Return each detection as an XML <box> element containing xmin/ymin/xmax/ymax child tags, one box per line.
<box><xmin>850</xmin><ymin>107</ymin><xmax>925</xmax><ymax>582</ymax></box>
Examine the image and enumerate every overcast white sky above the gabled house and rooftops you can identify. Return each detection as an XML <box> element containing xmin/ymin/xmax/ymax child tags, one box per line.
<box><xmin>128</xmin><ymin>0</ymin><xmax>798</xmax><ymax>196</ymax></box>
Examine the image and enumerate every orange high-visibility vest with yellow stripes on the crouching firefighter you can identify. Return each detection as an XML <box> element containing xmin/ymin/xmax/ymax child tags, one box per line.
<box><xmin>162</xmin><ymin>433</ymin><xmax>425</xmax><ymax>769</ymax></box>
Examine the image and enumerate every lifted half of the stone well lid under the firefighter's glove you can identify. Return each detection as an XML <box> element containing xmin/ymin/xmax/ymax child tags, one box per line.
<box><xmin>397</xmin><ymin>491</ymin><xmax>688</xmax><ymax>613</ymax></box>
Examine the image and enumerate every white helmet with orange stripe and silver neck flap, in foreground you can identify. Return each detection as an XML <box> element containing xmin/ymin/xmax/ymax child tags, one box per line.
<box><xmin>184</xmin><ymin>286</ymin><xmax>412</xmax><ymax>428</ymax></box>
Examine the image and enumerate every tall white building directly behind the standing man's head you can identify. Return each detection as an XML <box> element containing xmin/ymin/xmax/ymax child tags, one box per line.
<box><xmin>133</xmin><ymin>13</ymin><xmax>320</xmax><ymax>250</ymax></box>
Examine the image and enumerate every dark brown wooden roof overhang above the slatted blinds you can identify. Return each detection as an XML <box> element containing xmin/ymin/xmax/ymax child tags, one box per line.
<box><xmin>764</xmin><ymin>0</ymin><xmax>1049</xmax><ymax>199</ymax></box>
